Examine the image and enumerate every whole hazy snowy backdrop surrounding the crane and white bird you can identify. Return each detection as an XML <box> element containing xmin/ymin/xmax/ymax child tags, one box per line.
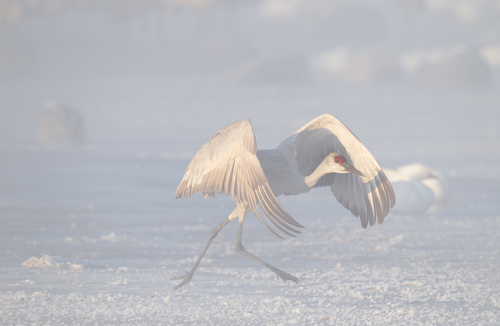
<box><xmin>0</xmin><ymin>0</ymin><xmax>500</xmax><ymax>325</ymax></box>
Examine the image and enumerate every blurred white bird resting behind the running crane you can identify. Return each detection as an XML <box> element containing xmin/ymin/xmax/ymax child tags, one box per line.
<box><xmin>384</xmin><ymin>163</ymin><xmax>449</xmax><ymax>215</ymax></box>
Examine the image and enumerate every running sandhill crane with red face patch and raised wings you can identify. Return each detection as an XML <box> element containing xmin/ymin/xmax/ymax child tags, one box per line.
<box><xmin>172</xmin><ymin>114</ymin><xmax>395</xmax><ymax>290</ymax></box>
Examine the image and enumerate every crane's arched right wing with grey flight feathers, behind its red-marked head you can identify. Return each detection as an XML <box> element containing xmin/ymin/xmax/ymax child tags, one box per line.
<box><xmin>286</xmin><ymin>114</ymin><xmax>396</xmax><ymax>228</ymax></box>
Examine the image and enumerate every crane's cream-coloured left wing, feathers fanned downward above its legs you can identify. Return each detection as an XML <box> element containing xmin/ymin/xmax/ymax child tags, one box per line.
<box><xmin>175</xmin><ymin>119</ymin><xmax>303</xmax><ymax>238</ymax></box>
